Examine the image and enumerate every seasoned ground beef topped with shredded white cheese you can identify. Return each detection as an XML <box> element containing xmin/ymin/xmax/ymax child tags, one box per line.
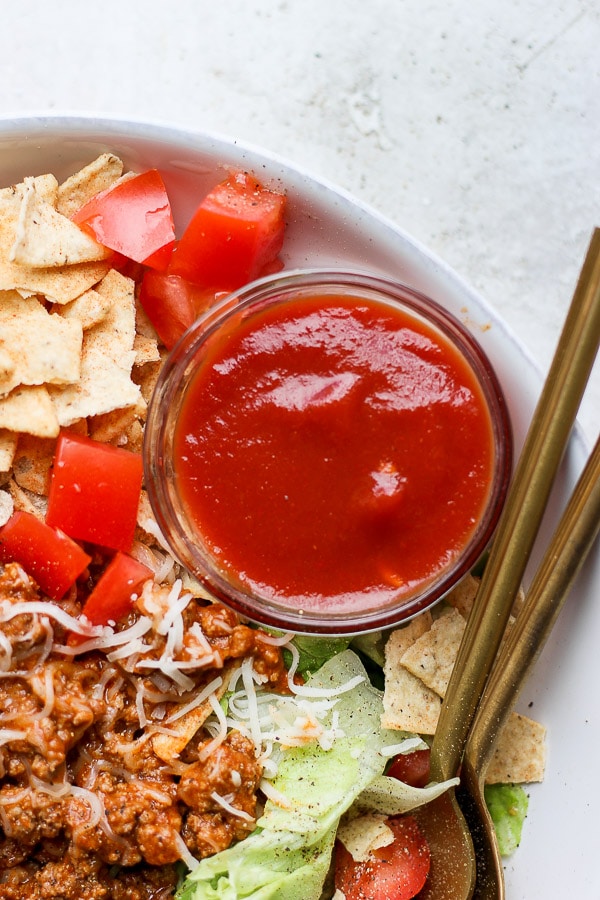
<box><xmin>0</xmin><ymin>564</ymin><xmax>286</xmax><ymax>900</ymax></box>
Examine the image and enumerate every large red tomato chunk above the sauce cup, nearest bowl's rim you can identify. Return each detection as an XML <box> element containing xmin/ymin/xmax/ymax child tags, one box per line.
<box><xmin>169</xmin><ymin>172</ymin><xmax>286</xmax><ymax>290</ymax></box>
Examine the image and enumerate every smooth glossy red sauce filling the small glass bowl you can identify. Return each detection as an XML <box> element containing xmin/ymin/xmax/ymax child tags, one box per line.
<box><xmin>175</xmin><ymin>297</ymin><xmax>494</xmax><ymax>610</ymax></box>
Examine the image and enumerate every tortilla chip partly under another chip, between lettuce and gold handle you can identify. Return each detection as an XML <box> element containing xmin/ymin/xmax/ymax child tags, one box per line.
<box><xmin>381</xmin><ymin>613</ymin><xmax>442</xmax><ymax>734</ymax></box>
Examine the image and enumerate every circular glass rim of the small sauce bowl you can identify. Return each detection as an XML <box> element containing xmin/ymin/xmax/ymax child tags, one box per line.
<box><xmin>143</xmin><ymin>266</ymin><xmax>513</xmax><ymax>637</ymax></box>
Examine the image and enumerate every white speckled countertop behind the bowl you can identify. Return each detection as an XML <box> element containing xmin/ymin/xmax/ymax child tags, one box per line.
<box><xmin>0</xmin><ymin>0</ymin><xmax>600</xmax><ymax>432</ymax></box>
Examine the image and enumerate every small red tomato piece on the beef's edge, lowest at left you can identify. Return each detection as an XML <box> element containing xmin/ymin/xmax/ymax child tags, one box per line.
<box><xmin>82</xmin><ymin>552</ymin><xmax>153</xmax><ymax>625</ymax></box>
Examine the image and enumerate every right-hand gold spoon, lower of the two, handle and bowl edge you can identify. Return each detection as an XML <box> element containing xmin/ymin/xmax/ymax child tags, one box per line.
<box><xmin>457</xmin><ymin>438</ymin><xmax>600</xmax><ymax>900</ymax></box>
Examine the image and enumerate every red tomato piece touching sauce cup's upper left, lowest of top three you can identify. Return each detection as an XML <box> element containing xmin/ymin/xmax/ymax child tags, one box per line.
<box><xmin>139</xmin><ymin>269</ymin><xmax>226</xmax><ymax>350</ymax></box>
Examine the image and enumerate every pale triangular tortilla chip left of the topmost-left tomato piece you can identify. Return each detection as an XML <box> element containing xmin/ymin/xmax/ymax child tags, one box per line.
<box><xmin>9</xmin><ymin>178</ymin><xmax>111</xmax><ymax>269</ymax></box>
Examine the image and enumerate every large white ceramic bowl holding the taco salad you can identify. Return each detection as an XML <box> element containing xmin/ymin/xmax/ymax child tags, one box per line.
<box><xmin>0</xmin><ymin>117</ymin><xmax>600</xmax><ymax>900</ymax></box>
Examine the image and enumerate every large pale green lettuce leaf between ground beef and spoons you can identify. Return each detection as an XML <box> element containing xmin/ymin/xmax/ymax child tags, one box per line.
<box><xmin>177</xmin><ymin>650</ymin><xmax>456</xmax><ymax>900</ymax></box>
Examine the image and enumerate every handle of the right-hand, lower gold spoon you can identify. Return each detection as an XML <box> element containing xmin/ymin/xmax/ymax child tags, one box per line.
<box><xmin>465</xmin><ymin>438</ymin><xmax>600</xmax><ymax>776</ymax></box>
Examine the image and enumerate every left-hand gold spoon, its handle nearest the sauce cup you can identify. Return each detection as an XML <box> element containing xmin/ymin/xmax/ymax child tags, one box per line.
<box><xmin>419</xmin><ymin>228</ymin><xmax>600</xmax><ymax>900</ymax></box>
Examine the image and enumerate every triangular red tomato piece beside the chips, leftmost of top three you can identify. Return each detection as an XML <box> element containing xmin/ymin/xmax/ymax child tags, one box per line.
<box><xmin>73</xmin><ymin>169</ymin><xmax>175</xmax><ymax>269</ymax></box>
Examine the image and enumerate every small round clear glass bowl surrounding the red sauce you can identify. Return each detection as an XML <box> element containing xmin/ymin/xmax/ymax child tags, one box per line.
<box><xmin>144</xmin><ymin>269</ymin><xmax>512</xmax><ymax>635</ymax></box>
